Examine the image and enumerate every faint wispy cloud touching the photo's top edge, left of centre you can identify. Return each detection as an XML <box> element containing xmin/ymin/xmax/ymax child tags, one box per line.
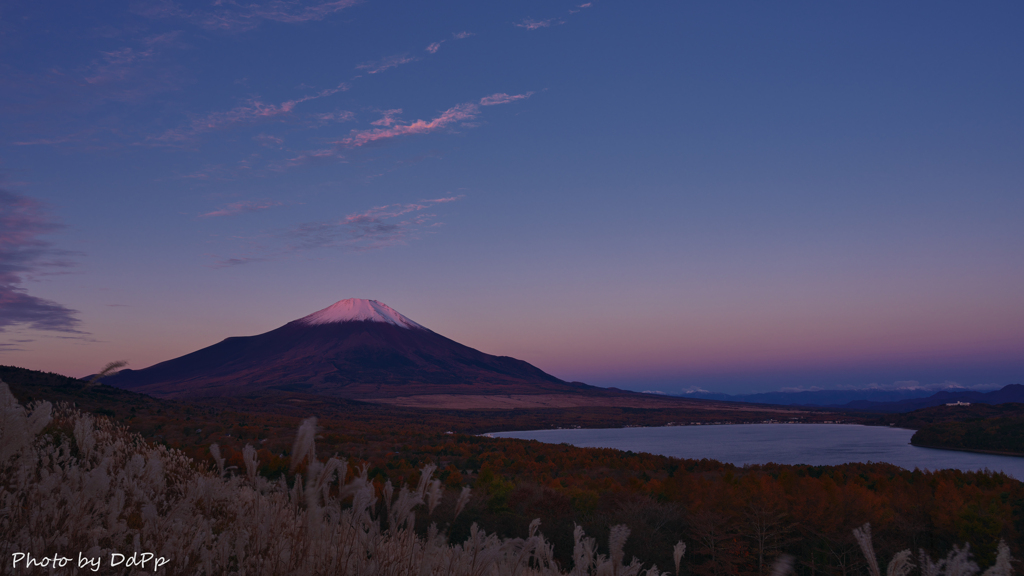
<box><xmin>131</xmin><ymin>0</ymin><xmax>358</xmax><ymax>32</ymax></box>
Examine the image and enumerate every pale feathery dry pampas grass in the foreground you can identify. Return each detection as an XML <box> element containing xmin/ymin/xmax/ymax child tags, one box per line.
<box><xmin>0</xmin><ymin>381</ymin><xmax>1014</xmax><ymax>576</ymax></box>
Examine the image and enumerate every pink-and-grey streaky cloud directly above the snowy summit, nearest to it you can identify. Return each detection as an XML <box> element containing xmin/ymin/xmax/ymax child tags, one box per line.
<box><xmin>215</xmin><ymin>196</ymin><xmax>462</xmax><ymax>268</ymax></box>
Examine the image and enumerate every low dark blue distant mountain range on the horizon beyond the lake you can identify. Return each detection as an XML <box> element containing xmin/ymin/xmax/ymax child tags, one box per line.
<box><xmin>684</xmin><ymin>384</ymin><xmax>1024</xmax><ymax>412</ymax></box>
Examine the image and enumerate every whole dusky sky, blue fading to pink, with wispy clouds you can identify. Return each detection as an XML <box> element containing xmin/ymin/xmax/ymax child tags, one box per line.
<box><xmin>0</xmin><ymin>0</ymin><xmax>1024</xmax><ymax>393</ymax></box>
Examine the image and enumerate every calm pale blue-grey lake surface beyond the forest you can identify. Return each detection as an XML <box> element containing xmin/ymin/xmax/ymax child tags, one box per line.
<box><xmin>490</xmin><ymin>424</ymin><xmax>1024</xmax><ymax>481</ymax></box>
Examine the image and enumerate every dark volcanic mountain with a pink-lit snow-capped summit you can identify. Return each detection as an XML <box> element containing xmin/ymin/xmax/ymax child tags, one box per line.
<box><xmin>103</xmin><ymin>298</ymin><xmax>608</xmax><ymax>400</ymax></box>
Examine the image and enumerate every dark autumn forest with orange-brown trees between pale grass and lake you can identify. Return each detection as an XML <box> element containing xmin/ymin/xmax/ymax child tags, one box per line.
<box><xmin>0</xmin><ymin>369</ymin><xmax>1024</xmax><ymax>576</ymax></box>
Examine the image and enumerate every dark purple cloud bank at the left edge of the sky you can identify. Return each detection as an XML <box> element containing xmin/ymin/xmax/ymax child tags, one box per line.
<box><xmin>0</xmin><ymin>189</ymin><xmax>85</xmax><ymax>334</ymax></box>
